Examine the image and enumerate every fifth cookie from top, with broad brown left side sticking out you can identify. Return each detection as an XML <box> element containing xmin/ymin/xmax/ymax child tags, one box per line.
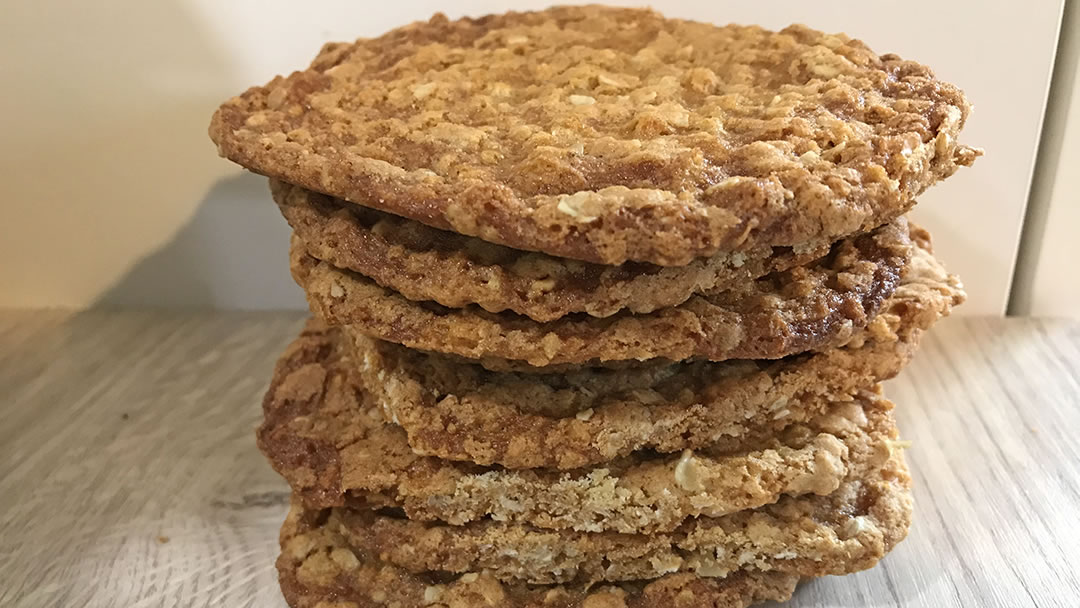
<box><xmin>258</xmin><ymin>322</ymin><xmax>896</xmax><ymax>532</ymax></box>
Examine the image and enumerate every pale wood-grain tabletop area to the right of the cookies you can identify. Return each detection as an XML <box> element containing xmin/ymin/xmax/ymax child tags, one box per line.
<box><xmin>777</xmin><ymin>319</ymin><xmax>1080</xmax><ymax>608</ymax></box>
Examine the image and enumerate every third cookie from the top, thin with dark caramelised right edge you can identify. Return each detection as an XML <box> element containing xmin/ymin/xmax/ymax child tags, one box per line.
<box><xmin>292</xmin><ymin>218</ymin><xmax>913</xmax><ymax>366</ymax></box>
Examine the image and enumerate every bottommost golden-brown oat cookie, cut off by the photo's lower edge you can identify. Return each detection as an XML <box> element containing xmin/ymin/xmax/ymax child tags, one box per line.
<box><xmin>278</xmin><ymin>501</ymin><xmax>799</xmax><ymax>608</ymax></box>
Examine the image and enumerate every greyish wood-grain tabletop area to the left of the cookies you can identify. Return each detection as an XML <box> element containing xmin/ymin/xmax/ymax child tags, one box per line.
<box><xmin>0</xmin><ymin>313</ymin><xmax>299</xmax><ymax>607</ymax></box>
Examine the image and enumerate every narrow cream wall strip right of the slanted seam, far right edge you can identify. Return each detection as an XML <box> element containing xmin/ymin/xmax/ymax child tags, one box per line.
<box><xmin>1010</xmin><ymin>2</ymin><xmax>1080</xmax><ymax>319</ymax></box>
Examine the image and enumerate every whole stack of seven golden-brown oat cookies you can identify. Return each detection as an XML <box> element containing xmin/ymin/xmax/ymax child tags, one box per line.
<box><xmin>211</xmin><ymin>6</ymin><xmax>980</xmax><ymax>608</ymax></box>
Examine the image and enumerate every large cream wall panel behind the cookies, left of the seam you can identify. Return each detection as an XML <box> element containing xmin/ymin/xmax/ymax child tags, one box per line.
<box><xmin>0</xmin><ymin>0</ymin><xmax>1063</xmax><ymax>314</ymax></box>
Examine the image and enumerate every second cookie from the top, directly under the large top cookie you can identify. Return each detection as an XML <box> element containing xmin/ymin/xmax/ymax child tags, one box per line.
<box><xmin>270</xmin><ymin>180</ymin><xmax>832</xmax><ymax>322</ymax></box>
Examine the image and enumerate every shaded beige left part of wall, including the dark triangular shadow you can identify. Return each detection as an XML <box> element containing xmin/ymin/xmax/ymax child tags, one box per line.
<box><xmin>0</xmin><ymin>0</ymin><xmax>302</xmax><ymax>309</ymax></box>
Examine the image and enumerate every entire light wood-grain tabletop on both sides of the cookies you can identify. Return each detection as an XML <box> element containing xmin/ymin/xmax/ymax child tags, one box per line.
<box><xmin>0</xmin><ymin>312</ymin><xmax>1080</xmax><ymax>608</ymax></box>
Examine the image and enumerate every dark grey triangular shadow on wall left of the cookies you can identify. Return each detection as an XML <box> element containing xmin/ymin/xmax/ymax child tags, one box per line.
<box><xmin>94</xmin><ymin>173</ymin><xmax>306</xmax><ymax>310</ymax></box>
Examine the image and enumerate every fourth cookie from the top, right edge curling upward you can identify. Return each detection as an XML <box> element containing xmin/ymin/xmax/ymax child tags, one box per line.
<box><xmin>354</xmin><ymin>237</ymin><xmax>964</xmax><ymax>469</ymax></box>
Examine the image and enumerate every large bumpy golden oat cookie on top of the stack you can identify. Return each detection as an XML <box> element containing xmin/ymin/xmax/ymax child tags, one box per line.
<box><xmin>211</xmin><ymin>6</ymin><xmax>978</xmax><ymax>266</ymax></box>
